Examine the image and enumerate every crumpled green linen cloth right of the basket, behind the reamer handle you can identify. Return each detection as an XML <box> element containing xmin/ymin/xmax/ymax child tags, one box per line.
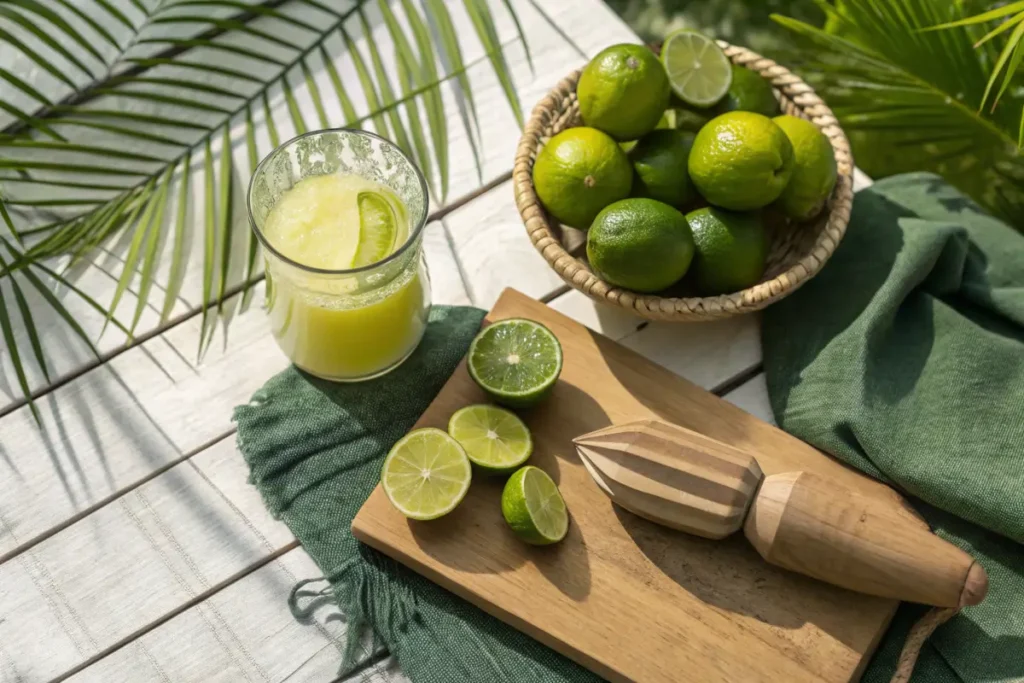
<box><xmin>763</xmin><ymin>174</ymin><xmax>1024</xmax><ymax>683</ymax></box>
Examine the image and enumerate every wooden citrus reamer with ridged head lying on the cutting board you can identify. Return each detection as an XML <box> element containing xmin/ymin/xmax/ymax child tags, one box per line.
<box><xmin>573</xmin><ymin>420</ymin><xmax>988</xmax><ymax>608</ymax></box>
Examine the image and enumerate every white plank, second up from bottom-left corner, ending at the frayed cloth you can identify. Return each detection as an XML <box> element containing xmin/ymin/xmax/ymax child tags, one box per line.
<box><xmin>0</xmin><ymin>439</ymin><xmax>294</xmax><ymax>681</ymax></box>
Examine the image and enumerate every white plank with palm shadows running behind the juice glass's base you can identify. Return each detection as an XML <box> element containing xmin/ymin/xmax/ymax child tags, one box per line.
<box><xmin>0</xmin><ymin>222</ymin><xmax>468</xmax><ymax>559</ymax></box>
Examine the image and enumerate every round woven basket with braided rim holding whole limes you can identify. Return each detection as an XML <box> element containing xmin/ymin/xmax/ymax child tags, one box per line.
<box><xmin>512</xmin><ymin>41</ymin><xmax>853</xmax><ymax>322</ymax></box>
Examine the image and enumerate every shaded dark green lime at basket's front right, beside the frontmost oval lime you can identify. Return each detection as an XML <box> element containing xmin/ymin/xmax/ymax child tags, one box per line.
<box><xmin>686</xmin><ymin>207</ymin><xmax>768</xmax><ymax>296</ymax></box>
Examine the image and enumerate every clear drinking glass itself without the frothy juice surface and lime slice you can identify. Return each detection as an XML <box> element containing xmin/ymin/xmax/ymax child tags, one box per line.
<box><xmin>248</xmin><ymin>129</ymin><xmax>430</xmax><ymax>382</ymax></box>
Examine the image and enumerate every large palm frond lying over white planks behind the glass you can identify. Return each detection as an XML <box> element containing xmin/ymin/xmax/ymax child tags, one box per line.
<box><xmin>0</xmin><ymin>0</ymin><xmax>531</xmax><ymax>417</ymax></box>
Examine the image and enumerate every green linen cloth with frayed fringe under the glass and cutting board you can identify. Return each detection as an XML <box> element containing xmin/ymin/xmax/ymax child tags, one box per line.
<box><xmin>234</xmin><ymin>306</ymin><xmax>600</xmax><ymax>683</ymax></box>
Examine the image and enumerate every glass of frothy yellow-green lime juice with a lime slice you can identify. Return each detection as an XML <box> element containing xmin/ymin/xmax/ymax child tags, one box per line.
<box><xmin>248</xmin><ymin>129</ymin><xmax>430</xmax><ymax>382</ymax></box>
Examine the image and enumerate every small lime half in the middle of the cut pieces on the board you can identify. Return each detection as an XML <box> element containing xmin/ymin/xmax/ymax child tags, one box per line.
<box><xmin>449</xmin><ymin>405</ymin><xmax>534</xmax><ymax>474</ymax></box>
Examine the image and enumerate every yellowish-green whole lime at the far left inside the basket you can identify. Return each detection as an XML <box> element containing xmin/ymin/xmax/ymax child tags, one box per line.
<box><xmin>534</xmin><ymin>127</ymin><xmax>633</xmax><ymax>230</ymax></box>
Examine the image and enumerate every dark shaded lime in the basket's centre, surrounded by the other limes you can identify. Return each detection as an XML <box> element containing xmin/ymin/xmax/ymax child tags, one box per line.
<box><xmin>630</xmin><ymin>129</ymin><xmax>694</xmax><ymax>207</ymax></box>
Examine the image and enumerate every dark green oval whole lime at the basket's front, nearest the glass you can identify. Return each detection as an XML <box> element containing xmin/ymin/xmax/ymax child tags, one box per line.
<box><xmin>587</xmin><ymin>198</ymin><xmax>693</xmax><ymax>292</ymax></box>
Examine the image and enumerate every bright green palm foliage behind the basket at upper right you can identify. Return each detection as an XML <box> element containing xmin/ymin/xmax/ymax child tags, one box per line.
<box><xmin>773</xmin><ymin>0</ymin><xmax>1024</xmax><ymax>227</ymax></box>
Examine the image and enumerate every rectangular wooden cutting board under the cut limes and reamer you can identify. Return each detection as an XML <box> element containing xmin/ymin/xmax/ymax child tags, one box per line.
<box><xmin>352</xmin><ymin>290</ymin><xmax>909</xmax><ymax>683</ymax></box>
